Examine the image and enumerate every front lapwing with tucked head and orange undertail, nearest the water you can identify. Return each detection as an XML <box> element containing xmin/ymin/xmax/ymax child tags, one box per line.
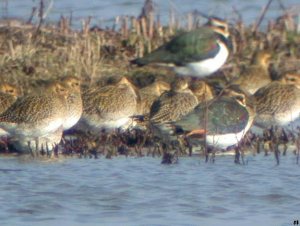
<box><xmin>172</xmin><ymin>86</ymin><xmax>255</xmax><ymax>150</ymax></box>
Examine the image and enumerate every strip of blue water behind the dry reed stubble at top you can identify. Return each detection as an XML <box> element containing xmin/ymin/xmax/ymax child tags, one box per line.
<box><xmin>0</xmin><ymin>0</ymin><xmax>300</xmax><ymax>27</ymax></box>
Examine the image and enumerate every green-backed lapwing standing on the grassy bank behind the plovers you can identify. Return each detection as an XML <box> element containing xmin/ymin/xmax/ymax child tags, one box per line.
<box><xmin>131</xmin><ymin>17</ymin><xmax>232</xmax><ymax>77</ymax></box>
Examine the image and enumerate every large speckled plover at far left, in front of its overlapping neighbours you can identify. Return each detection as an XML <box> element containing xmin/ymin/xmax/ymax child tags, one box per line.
<box><xmin>0</xmin><ymin>81</ymin><xmax>67</xmax><ymax>137</ymax></box>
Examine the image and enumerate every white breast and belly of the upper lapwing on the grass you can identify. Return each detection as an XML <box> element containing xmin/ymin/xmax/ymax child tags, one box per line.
<box><xmin>174</xmin><ymin>41</ymin><xmax>229</xmax><ymax>77</ymax></box>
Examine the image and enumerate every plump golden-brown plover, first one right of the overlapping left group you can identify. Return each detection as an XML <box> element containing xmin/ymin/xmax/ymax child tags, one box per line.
<box><xmin>82</xmin><ymin>77</ymin><xmax>139</xmax><ymax>129</ymax></box>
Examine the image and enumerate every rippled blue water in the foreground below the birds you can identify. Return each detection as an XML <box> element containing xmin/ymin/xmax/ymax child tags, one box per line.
<box><xmin>0</xmin><ymin>154</ymin><xmax>300</xmax><ymax>226</ymax></box>
